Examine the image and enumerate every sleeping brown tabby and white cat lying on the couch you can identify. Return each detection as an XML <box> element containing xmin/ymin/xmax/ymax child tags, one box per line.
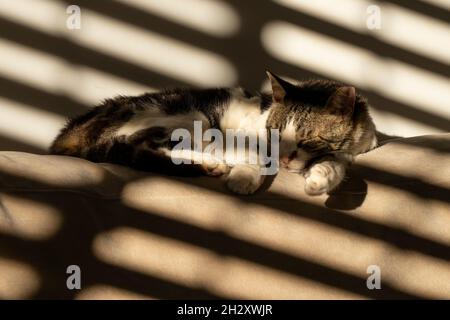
<box><xmin>50</xmin><ymin>72</ymin><xmax>377</xmax><ymax>195</ymax></box>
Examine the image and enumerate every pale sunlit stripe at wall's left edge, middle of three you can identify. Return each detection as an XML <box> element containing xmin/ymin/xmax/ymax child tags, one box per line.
<box><xmin>0</xmin><ymin>39</ymin><xmax>154</xmax><ymax>105</ymax></box>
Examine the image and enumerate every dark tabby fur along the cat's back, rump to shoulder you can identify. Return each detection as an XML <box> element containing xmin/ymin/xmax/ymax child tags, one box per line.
<box><xmin>50</xmin><ymin>88</ymin><xmax>230</xmax><ymax>156</ymax></box>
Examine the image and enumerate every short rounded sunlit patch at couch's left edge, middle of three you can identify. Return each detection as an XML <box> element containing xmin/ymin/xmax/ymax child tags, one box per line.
<box><xmin>0</xmin><ymin>194</ymin><xmax>62</xmax><ymax>240</ymax></box>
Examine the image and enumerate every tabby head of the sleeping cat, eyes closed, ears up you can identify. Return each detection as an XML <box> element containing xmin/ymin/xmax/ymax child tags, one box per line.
<box><xmin>267</xmin><ymin>72</ymin><xmax>376</xmax><ymax>171</ymax></box>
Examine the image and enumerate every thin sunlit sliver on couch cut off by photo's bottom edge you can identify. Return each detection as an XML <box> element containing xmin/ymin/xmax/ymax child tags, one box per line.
<box><xmin>75</xmin><ymin>284</ymin><xmax>155</xmax><ymax>300</ymax></box>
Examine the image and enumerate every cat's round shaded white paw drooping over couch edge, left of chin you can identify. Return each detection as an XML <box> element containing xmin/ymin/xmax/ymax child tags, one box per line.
<box><xmin>227</xmin><ymin>165</ymin><xmax>264</xmax><ymax>194</ymax></box>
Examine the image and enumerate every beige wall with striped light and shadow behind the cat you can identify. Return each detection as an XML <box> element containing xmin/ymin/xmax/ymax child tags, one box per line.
<box><xmin>0</xmin><ymin>0</ymin><xmax>450</xmax><ymax>152</ymax></box>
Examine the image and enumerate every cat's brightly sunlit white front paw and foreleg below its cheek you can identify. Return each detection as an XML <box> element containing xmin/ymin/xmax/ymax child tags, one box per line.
<box><xmin>304</xmin><ymin>156</ymin><xmax>350</xmax><ymax>196</ymax></box>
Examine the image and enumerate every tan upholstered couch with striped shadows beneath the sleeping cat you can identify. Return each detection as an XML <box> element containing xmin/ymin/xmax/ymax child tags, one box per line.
<box><xmin>0</xmin><ymin>134</ymin><xmax>450</xmax><ymax>299</ymax></box>
